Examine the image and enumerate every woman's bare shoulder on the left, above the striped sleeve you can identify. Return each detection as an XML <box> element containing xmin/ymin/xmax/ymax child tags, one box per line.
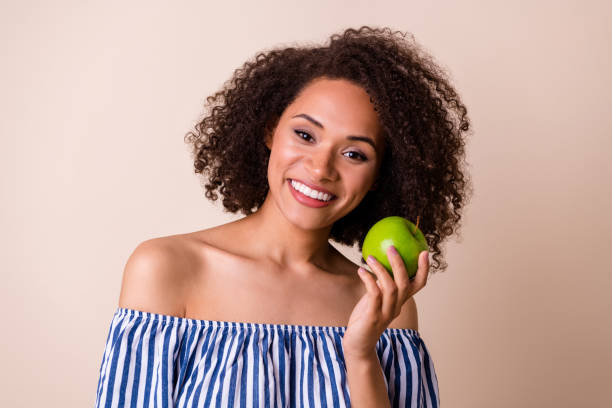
<box><xmin>119</xmin><ymin>235</ymin><xmax>198</xmax><ymax>317</ymax></box>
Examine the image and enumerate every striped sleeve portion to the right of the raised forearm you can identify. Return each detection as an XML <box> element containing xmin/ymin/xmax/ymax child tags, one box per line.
<box><xmin>378</xmin><ymin>329</ymin><xmax>440</xmax><ymax>408</ymax></box>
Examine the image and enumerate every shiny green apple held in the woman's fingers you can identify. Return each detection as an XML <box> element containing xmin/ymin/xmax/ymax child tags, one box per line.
<box><xmin>362</xmin><ymin>216</ymin><xmax>429</xmax><ymax>278</ymax></box>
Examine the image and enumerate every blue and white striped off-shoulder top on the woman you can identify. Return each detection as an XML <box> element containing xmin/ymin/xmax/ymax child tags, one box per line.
<box><xmin>95</xmin><ymin>308</ymin><xmax>440</xmax><ymax>408</ymax></box>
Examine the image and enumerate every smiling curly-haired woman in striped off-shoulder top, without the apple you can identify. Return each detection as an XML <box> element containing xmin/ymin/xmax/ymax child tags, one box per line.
<box><xmin>96</xmin><ymin>27</ymin><xmax>469</xmax><ymax>407</ymax></box>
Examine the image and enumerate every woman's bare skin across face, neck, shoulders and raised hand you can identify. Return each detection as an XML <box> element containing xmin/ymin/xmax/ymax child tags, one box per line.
<box><xmin>119</xmin><ymin>79</ymin><xmax>427</xmax><ymax>332</ymax></box>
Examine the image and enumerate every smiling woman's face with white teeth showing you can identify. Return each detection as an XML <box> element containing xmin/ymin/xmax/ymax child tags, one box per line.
<box><xmin>266</xmin><ymin>79</ymin><xmax>384</xmax><ymax>229</ymax></box>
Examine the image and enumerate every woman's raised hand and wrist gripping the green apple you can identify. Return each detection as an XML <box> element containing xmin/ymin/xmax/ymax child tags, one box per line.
<box><xmin>342</xmin><ymin>246</ymin><xmax>429</xmax><ymax>358</ymax></box>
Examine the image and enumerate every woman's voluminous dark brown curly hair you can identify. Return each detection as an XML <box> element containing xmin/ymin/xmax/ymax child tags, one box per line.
<box><xmin>185</xmin><ymin>26</ymin><xmax>471</xmax><ymax>273</ymax></box>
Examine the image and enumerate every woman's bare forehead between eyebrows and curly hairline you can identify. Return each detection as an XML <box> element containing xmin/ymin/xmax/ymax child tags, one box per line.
<box><xmin>283</xmin><ymin>79</ymin><xmax>379</xmax><ymax>143</ymax></box>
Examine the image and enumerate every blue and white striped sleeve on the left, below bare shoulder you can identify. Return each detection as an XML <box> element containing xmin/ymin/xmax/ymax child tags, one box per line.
<box><xmin>95</xmin><ymin>309</ymin><xmax>179</xmax><ymax>408</ymax></box>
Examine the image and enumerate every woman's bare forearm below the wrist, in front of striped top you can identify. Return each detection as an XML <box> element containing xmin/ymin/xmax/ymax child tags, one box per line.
<box><xmin>344</xmin><ymin>350</ymin><xmax>391</xmax><ymax>408</ymax></box>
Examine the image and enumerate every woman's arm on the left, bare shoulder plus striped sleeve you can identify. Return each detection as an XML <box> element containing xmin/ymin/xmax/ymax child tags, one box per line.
<box><xmin>95</xmin><ymin>239</ymin><xmax>185</xmax><ymax>408</ymax></box>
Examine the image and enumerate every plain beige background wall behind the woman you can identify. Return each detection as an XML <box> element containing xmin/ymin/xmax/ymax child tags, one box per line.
<box><xmin>0</xmin><ymin>0</ymin><xmax>612</xmax><ymax>408</ymax></box>
